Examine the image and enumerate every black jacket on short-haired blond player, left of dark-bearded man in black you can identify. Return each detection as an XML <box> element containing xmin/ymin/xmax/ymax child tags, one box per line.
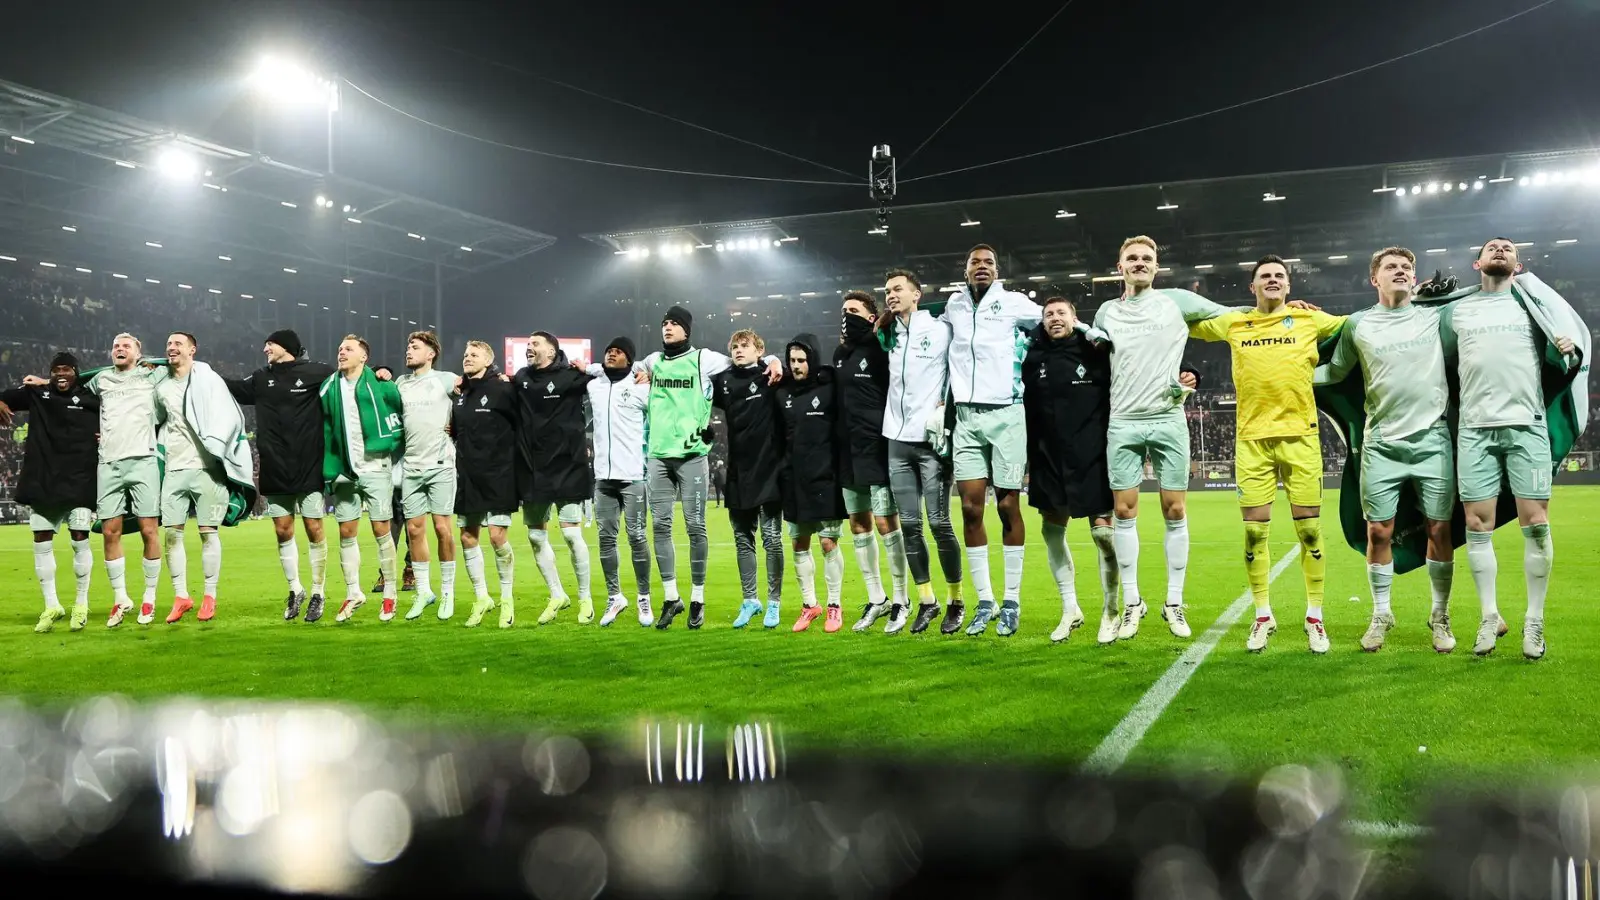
<box><xmin>450</xmin><ymin>365</ymin><xmax>522</xmax><ymax>514</ymax></box>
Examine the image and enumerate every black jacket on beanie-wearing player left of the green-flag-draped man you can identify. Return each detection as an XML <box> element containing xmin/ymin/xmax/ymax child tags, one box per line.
<box><xmin>227</xmin><ymin>359</ymin><xmax>334</xmax><ymax>496</ymax></box>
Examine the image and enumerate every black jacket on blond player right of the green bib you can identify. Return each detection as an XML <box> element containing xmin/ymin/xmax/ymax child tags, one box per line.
<box><xmin>712</xmin><ymin>364</ymin><xmax>784</xmax><ymax>509</ymax></box>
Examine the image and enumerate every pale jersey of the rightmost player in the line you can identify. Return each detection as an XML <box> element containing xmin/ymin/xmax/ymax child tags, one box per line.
<box><xmin>1445</xmin><ymin>291</ymin><xmax>1544</xmax><ymax>428</ymax></box>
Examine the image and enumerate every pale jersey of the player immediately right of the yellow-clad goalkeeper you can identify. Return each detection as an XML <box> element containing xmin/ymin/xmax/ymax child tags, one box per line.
<box><xmin>1328</xmin><ymin>303</ymin><xmax>1450</xmax><ymax>440</ymax></box>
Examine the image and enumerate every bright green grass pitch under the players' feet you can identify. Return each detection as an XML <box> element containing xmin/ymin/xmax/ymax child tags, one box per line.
<box><xmin>0</xmin><ymin>487</ymin><xmax>1600</xmax><ymax>822</ymax></box>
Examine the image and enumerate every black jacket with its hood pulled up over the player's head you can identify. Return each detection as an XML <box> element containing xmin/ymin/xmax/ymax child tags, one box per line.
<box><xmin>778</xmin><ymin>333</ymin><xmax>846</xmax><ymax>522</ymax></box>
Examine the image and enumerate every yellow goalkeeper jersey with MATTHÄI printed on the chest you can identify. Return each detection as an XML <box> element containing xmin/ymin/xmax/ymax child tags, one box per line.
<box><xmin>1190</xmin><ymin>306</ymin><xmax>1344</xmax><ymax>440</ymax></box>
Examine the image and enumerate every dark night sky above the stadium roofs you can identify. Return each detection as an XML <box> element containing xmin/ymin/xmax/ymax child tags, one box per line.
<box><xmin>0</xmin><ymin>0</ymin><xmax>1600</xmax><ymax>336</ymax></box>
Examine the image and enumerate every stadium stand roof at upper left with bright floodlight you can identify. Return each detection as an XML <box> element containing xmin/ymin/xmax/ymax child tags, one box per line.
<box><xmin>0</xmin><ymin>74</ymin><xmax>555</xmax><ymax>293</ymax></box>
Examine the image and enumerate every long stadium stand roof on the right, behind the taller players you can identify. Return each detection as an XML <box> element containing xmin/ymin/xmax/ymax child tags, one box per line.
<box><xmin>584</xmin><ymin>151</ymin><xmax>1600</xmax><ymax>283</ymax></box>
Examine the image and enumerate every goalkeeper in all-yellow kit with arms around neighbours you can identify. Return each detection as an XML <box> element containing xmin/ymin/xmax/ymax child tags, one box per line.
<box><xmin>1189</xmin><ymin>256</ymin><xmax>1344</xmax><ymax>653</ymax></box>
